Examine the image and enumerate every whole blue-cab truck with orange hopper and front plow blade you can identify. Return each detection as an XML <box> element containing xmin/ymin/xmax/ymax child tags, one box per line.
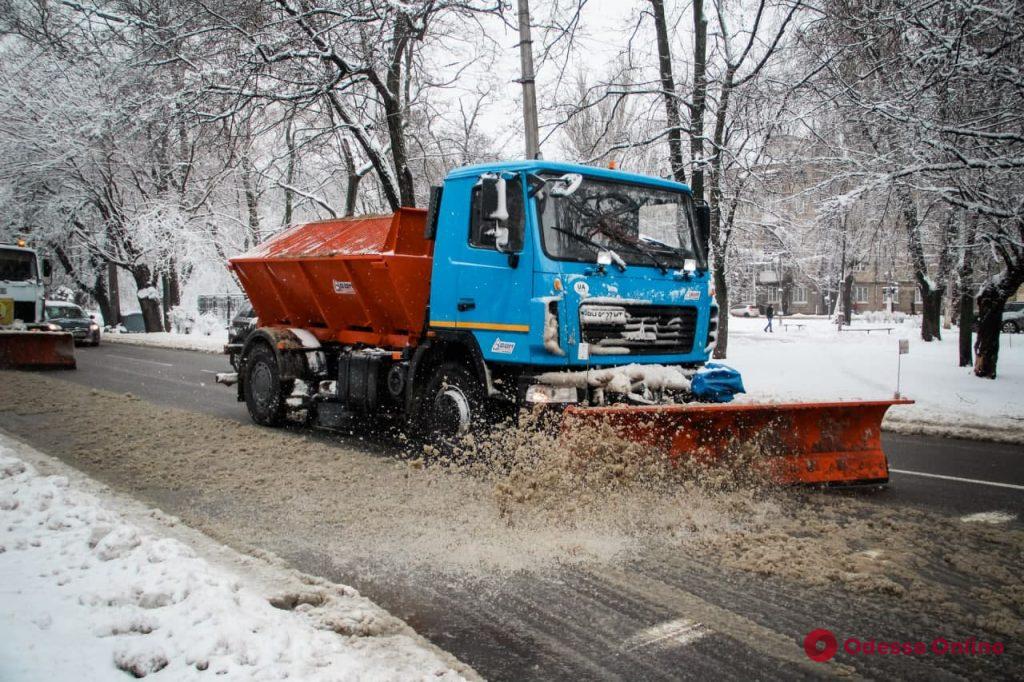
<box><xmin>220</xmin><ymin>161</ymin><xmax>894</xmax><ymax>483</ymax></box>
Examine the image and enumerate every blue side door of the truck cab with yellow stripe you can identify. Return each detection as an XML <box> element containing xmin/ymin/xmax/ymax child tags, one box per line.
<box><xmin>456</xmin><ymin>173</ymin><xmax>543</xmax><ymax>363</ymax></box>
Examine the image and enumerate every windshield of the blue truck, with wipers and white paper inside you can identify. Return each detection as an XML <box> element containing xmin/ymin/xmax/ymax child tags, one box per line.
<box><xmin>537</xmin><ymin>176</ymin><xmax>697</xmax><ymax>269</ymax></box>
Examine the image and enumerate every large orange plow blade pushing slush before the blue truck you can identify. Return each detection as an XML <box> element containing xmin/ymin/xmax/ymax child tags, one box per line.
<box><xmin>564</xmin><ymin>400</ymin><xmax>913</xmax><ymax>484</ymax></box>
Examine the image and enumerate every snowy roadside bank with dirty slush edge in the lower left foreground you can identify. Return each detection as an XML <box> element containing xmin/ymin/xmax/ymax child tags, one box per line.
<box><xmin>0</xmin><ymin>434</ymin><xmax>476</xmax><ymax>682</ymax></box>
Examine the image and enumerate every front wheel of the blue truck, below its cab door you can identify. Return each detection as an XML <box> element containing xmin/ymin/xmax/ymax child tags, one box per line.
<box><xmin>420</xmin><ymin>363</ymin><xmax>483</xmax><ymax>446</ymax></box>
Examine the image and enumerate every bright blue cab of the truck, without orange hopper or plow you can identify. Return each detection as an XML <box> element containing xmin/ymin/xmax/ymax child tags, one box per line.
<box><xmin>419</xmin><ymin>161</ymin><xmax>718</xmax><ymax>403</ymax></box>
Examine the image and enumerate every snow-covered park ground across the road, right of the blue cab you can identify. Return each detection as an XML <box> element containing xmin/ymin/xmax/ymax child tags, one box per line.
<box><xmin>724</xmin><ymin>317</ymin><xmax>1024</xmax><ymax>442</ymax></box>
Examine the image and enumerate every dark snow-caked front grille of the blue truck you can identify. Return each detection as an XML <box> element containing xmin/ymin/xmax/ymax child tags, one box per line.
<box><xmin>580</xmin><ymin>304</ymin><xmax>697</xmax><ymax>355</ymax></box>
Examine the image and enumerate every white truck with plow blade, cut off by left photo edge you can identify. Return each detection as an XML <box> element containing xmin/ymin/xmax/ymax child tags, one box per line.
<box><xmin>0</xmin><ymin>240</ymin><xmax>75</xmax><ymax>370</ymax></box>
